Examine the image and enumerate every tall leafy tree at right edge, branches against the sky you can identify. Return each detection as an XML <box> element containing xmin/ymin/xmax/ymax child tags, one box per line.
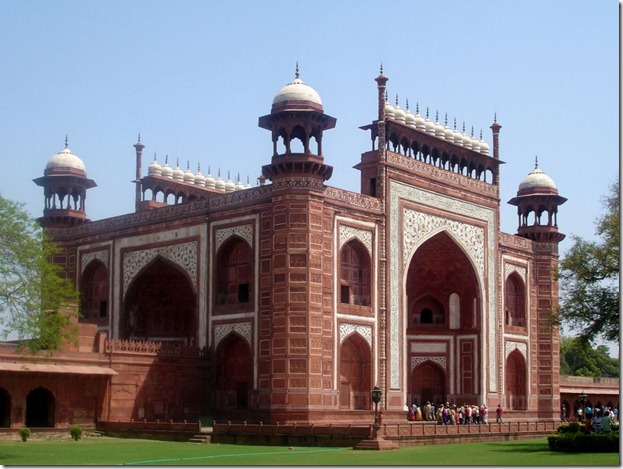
<box><xmin>559</xmin><ymin>177</ymin><xmax>621</xmax><ymax>342</ymax></box>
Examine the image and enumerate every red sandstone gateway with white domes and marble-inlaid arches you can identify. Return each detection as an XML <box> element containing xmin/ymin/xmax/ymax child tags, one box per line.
<box><xmin>0</xmin><ymin>67</ymin><xmax>618</xmax><ymax>428</ymax></box>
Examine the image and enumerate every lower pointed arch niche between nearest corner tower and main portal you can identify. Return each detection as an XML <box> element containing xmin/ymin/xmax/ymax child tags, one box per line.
<box><xmin>339</xmin><ymin>332</ymin><xmax>372</xmax><ymax>410</ymax></box>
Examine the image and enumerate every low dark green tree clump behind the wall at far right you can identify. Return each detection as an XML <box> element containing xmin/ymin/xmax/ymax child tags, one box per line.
<box><xmin>560</xmin><ymin>336</ymin><xmax>619</xmax><ymax>378</ymax></box>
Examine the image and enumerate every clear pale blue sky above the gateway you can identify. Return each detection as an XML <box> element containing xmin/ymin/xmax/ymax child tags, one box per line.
<box><xmin>0</xmin><ymin>0</ymin><xmax>620</xmax><ymax>252</ymax></box>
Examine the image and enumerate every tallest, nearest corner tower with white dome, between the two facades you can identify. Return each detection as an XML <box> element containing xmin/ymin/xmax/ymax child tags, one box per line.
<box><xmin>257</xmin><ymin>66</ymin><xmax>338</xmax><ymax>422</ymax></box>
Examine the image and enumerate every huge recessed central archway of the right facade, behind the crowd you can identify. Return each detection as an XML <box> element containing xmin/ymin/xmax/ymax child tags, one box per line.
<box><xmin>403</xmin><ymin>231</ymin><xmax>482</xmax><ymax>405</ymax></box>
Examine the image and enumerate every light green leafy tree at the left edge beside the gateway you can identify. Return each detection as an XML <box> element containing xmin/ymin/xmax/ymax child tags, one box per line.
<box><xmin>0</xmin><ymin>196</ymin><xmax>78</xmax><ymax>354</ymax></box>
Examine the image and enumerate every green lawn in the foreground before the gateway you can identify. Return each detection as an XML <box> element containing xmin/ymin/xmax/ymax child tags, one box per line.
<box><xmin>0</xmin><ymin>437</ymin><xmax>620</xmax><ymax>466</ymax></box>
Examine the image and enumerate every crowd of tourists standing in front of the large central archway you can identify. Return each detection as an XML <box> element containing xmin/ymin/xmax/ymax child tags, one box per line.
<box><xmin>405</xmin><ymin>401</ymin><xmax>504</xmax><ymax>425</ymax></box>
